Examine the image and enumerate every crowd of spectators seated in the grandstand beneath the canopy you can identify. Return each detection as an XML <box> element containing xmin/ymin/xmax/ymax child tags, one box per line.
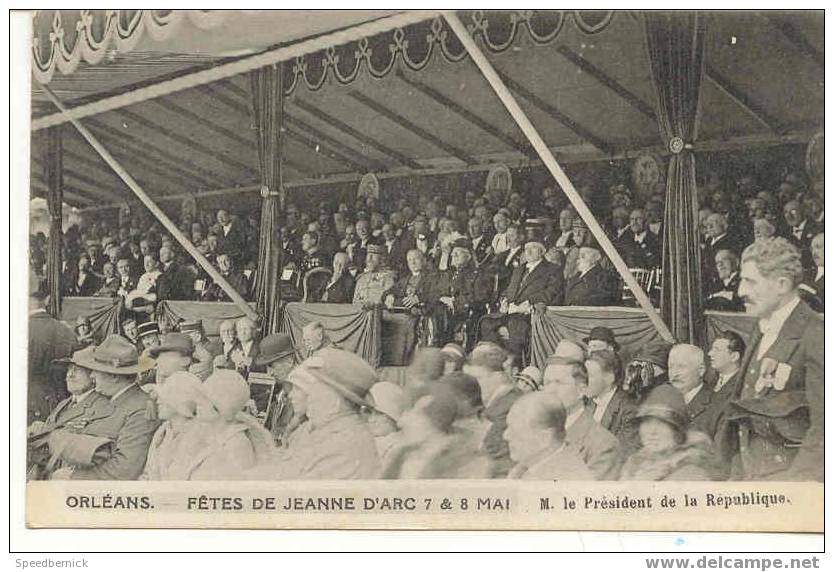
<box><xmin>31</xmin><ymin>168</ymin><xmax>825</xmax><ymax>362</ymax></box>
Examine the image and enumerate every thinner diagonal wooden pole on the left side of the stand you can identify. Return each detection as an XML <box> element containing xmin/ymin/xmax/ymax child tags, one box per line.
<box><xmin>41</xmin><ymin>85</ymin><xmax>258</xmax><ymax>321</ymax></box>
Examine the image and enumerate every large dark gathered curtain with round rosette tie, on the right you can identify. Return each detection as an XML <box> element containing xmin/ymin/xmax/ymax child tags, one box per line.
<box><xmin>645</xmin><ymin>12</ymin><xmax>706</xmax><ymax>343</ymax></box>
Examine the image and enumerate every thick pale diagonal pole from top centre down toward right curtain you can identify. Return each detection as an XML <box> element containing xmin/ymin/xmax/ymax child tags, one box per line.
<box><xmin>443</xmin><ymin>11</ymin><xmax>674</xmax><ymax>342</ymax></box>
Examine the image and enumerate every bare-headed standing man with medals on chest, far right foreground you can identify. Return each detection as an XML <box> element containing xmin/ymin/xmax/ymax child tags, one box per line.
<box><xmin>730</xmin><ymin>238</ymin><xmax>825</xmax><ymax>481</ymax></box>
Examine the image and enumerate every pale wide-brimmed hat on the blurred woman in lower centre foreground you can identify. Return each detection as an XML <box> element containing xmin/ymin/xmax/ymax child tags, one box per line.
<box><xmin>289</xmin><ymin>348</ymin><xmax>377</xmax><ymax>407</ymax></box>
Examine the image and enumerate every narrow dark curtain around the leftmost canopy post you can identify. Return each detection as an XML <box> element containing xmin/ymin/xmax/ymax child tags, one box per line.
<box><xmin>44</xmin><ymin>125</ymin><xmax>64</xmax><ymax>318</ymax></box>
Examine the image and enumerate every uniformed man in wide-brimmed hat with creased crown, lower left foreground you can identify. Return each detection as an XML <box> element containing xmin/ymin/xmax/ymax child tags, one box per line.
<box><xmin>42</xmin><ymin>334</ymin><xmax>159</xmax><ymax>481</ymax></box>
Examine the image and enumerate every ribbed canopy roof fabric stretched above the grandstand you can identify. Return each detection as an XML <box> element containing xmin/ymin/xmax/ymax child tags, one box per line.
<box><xmin>32</xmin><ymin>11</ymin><xmax>824</xmax><ymax>207</ymax></box>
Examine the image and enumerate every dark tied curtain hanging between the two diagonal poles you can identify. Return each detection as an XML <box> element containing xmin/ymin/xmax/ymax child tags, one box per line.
<box><xmin>249</xmin><ymin>64</ymin><xmax>284</xmax><ymax>335</ymax></box>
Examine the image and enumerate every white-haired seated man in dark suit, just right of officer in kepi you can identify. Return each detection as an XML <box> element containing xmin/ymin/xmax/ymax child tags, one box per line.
<box><xmin>481</xmin><ymin>242</ymin><xmax>562</xmax><ymax>357</ymax></box>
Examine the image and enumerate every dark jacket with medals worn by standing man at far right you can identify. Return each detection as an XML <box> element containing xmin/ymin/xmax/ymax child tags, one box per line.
<box><xmin>729</xmin><ymin>300</ymin><xmax>825</xmax><ymax>481</ymax></box>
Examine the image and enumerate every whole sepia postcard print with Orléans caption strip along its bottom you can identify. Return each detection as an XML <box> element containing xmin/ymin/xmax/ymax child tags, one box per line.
<box><xmin>17</xmin><ymin>9</ymin><xmax>825</xmax><ymax>532</ymax></box>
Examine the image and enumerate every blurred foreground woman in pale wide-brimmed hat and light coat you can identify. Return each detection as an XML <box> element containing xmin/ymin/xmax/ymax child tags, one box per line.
<box><xmin>264</xmin><ymin>348</ymin><xmax>381</xmax><ymax>480</ymax></box>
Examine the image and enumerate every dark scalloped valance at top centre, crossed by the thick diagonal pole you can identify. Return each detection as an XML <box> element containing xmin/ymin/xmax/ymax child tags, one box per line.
<box><xmin>284</xmin><ymin>10</ymin><xmax>616</xmax><ymax>95</ymax></box>
